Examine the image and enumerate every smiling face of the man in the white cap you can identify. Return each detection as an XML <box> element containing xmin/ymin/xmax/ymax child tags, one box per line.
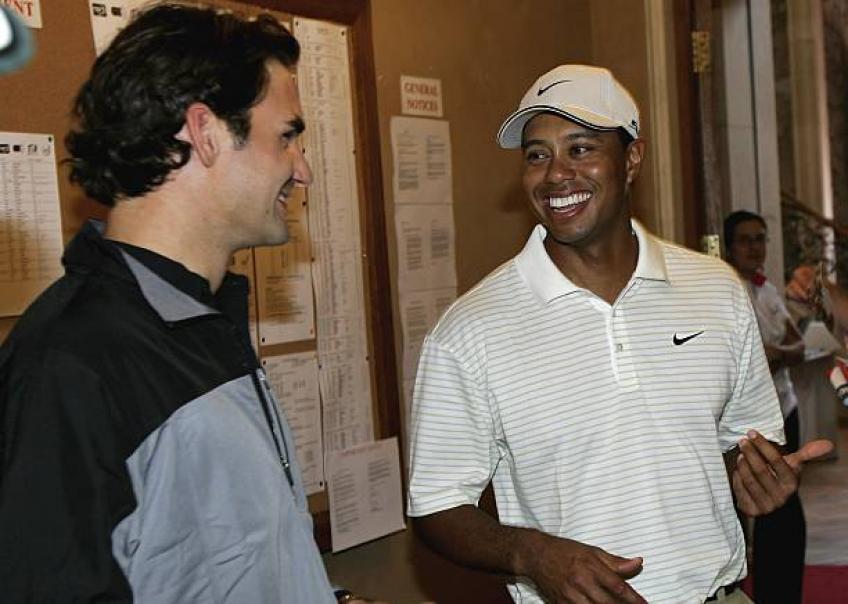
<box><xmin>522</xmin><ymin>113</ymin><xmax>644</xmax><ymax>247</ymax></box>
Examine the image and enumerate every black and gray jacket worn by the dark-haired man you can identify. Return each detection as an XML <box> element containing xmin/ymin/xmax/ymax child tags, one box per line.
<box><xmin>0</xmin><ymin>224</ymin><xmax>335</xmax><ymax>604</ymax></box>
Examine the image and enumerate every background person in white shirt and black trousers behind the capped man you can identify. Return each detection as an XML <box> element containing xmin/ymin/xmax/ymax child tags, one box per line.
<box><xmin>724</xmin><ymin>210</ymin><xmax>807</xmax><ymax>604</ymax></box>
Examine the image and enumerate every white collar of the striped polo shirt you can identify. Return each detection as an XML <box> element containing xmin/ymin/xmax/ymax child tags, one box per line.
<box><xmin>515</xmin><ymin>219</ymin><xmax>670</xmax><ymax>304</ymax></box>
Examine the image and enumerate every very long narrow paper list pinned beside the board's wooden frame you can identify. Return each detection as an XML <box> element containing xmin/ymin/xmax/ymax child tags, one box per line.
<box><xmin>293</xmin><ymin>18</ymin><xmax>374</xmax><ymax>451</ymax></box>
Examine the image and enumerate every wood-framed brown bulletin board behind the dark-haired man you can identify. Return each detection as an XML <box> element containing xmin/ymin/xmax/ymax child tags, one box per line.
<box><xmin>0</xmin><ymin>0</ymin><xmax>400</xmax><ymax>550</ymax></box>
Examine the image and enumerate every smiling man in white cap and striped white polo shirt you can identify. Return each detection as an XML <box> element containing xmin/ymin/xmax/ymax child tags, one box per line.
<box><xmin>408</xmin><ymin>65</ymin><xmax>831</xmax><ymax>603</ymax></box>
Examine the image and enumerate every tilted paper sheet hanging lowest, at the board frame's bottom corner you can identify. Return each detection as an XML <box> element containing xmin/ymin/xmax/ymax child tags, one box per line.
<box><xmin>327</xmin><ymin>437</ymin><xmax>405</xmax><ymax>552</ymax></box>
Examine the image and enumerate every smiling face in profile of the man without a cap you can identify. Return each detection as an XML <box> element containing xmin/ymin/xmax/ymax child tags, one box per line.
<box><xmin>216</xmin><ymin>62</ymin><xmax>312</xmax><ymax>249</ymax></box>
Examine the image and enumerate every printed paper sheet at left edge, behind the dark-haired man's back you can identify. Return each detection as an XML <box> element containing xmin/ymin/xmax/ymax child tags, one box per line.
<box><xmin>0</xmin><ymin>132</ymin><xmax>62</xmax><ymax>316</ymax></box>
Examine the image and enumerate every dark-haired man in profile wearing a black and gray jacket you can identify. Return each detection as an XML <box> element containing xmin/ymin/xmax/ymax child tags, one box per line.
<box><xmin>0</xmin><ymin>5</ymin><xmax>349</xmax><ymax>603</ymax></box>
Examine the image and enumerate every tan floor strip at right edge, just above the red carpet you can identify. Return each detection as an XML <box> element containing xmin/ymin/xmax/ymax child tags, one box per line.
<box><xmin>801</xmin><ymin>426</ymin><xmax>848</xmax><ymax>564</ymax></box>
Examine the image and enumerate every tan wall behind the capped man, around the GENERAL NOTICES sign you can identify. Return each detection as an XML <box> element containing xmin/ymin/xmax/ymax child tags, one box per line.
<box><xmin>371</xmin><ymin>0</ymin><xmax>592</xmax><ymax>291</ymax></box>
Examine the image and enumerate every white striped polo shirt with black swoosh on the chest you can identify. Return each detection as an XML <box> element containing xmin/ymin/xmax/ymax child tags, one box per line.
<box><xmin>408</xmin><ymin>221</ymin><xmax>783</xmax><ymax>604</ymax></box>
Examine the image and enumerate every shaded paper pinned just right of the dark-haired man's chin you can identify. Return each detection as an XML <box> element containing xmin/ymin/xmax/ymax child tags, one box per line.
<box><xmin>254</xmin><ymin>189</ymin><xmax>315</xmax><ymax>346</ymax></box>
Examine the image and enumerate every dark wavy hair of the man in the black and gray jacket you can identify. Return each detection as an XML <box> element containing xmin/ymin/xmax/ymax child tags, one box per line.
<box><xmin>65</xmin><ymin>4</ymin><xmax>300</xmax><ymax>206</ymax></box>
